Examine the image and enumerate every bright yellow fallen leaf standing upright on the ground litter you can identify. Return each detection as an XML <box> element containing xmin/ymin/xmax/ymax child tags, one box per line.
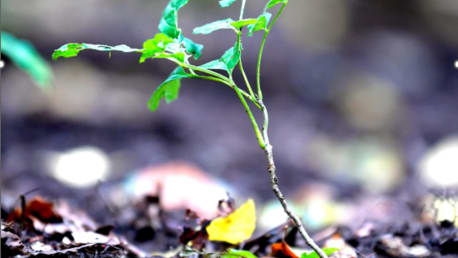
<box><xmin>207</xmin><ymin>199</ymin><xmax>256</xmax><ymax>245</ymax></box>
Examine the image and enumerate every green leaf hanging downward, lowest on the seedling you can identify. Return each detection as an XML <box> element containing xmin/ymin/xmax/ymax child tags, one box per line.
<box><xmin>148</xmin><ymin>66</ymin><xmax>193</xmax><ymax>112</ymax></box>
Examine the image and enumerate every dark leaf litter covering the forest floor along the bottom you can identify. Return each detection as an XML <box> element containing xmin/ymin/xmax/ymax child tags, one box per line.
<box><xmin>1</xmin><ymin>170</ymin><xmax>458</xmax><ymax>258</ymax></box>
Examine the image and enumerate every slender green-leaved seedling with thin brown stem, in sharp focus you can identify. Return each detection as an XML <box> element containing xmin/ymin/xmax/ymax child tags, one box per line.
<box><xmin>52</xmin><ymin>0</ymin><xmax>327</xmax><ymax>258</ymax></box>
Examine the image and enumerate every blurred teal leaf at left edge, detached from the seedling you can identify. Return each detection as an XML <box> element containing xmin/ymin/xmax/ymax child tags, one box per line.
<box><xmin>1</xmin><ymin>31</ymin><xmax>52</xmax><ymax>89</ymax></box>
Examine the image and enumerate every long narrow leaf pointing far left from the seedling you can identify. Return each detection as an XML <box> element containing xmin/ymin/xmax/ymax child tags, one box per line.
<box><xmin>52</xmin><ymin>43</ymin><xmax>142</xmax><ymax>60</ymax></box>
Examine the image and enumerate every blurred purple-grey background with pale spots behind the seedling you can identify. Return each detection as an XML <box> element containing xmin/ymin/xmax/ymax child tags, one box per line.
<box><xmin>1</xmin><ymin>0</ymin><xmax>458</xmax><ymax>234</ymax></box>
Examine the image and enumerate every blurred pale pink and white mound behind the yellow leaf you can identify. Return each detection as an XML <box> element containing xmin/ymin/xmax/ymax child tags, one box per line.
<box><xmin>124</xmin><ymin>162</ymin><xmax>230</xmax><ymax>219</ymax></box>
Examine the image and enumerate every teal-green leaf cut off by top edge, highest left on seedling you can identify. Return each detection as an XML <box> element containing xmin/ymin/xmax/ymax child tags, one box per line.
<box><xmin>158</xmin><ymin>0</ymin><xmax>189</xmax><ymax>39</ymax></box>
